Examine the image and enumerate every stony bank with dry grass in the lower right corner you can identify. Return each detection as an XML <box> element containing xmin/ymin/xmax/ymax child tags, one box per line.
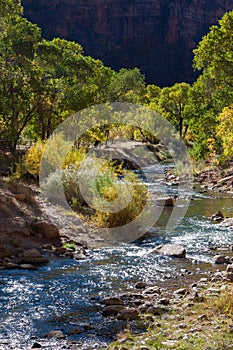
<box><xmin>108</xmin><ymin>268</ymin><xmax>233</xmax><ymax>350</ymax></box>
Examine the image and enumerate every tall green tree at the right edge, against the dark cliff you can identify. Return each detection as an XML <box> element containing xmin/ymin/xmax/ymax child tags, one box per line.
<box><xmin>186</xmin><ymin>11</ymin><xmax>233</xmax><ymax>158</ymax></box>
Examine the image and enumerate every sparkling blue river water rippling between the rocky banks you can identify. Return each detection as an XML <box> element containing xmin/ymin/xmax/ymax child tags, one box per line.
<box><xmin>0</xmin><ymin>168</ymin><xmax>233</xmax><ymax>350</ymax></box>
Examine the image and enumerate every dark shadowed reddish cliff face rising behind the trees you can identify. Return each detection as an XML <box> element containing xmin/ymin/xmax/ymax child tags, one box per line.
<box><xmin>22</xmin><ymin>0</ymin><xmax>233</xmax><ymax>86</ymax></box>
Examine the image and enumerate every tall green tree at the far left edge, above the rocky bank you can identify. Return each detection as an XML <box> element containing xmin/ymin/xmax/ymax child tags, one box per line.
<box><xmin>0</xmin><ymin>5</ymin><xmax>41</xmax><ymax>148</ymax></box>
